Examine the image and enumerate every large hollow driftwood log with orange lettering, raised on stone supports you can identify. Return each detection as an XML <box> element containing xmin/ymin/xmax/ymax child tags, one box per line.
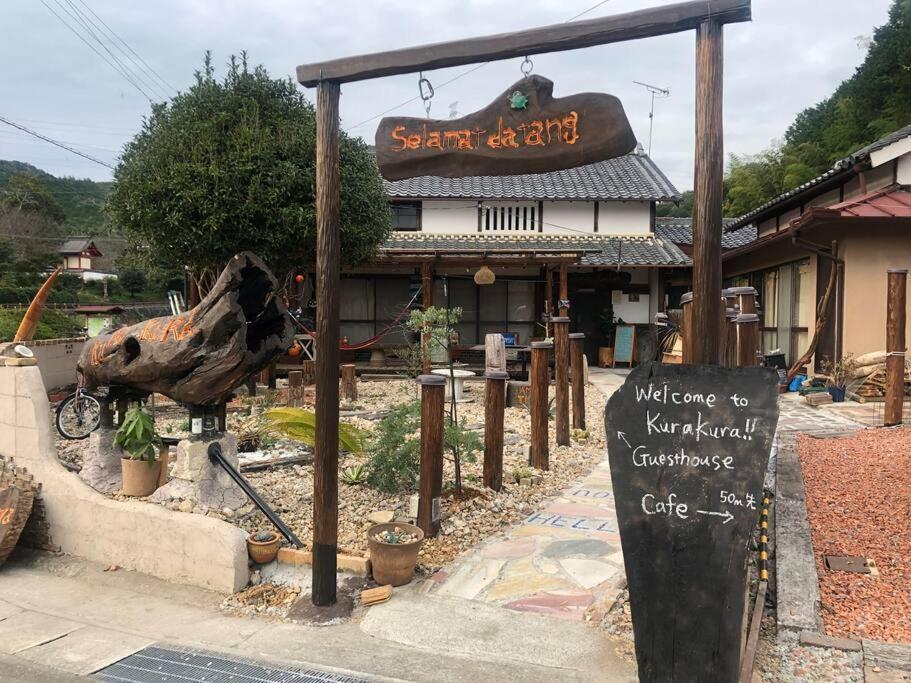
<box><xmin>78</xmin><ymin>252</ymin><xmax>293</xmax><ymax>405</ymax></box>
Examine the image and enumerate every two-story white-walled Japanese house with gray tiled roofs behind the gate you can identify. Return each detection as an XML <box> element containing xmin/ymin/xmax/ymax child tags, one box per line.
<box><xmin>330</xmin><ymin>153</ymin><xmax>690</xmax><ymax>362</ymax></box>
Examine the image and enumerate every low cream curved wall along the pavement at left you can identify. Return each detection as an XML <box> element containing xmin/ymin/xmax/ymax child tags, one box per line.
<box><xmin>0</xmin><ymin>366</ymin><xmax>249</xmax><ymax>593</ymax></box>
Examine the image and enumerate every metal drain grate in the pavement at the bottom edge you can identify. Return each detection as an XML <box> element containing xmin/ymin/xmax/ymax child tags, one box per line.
<box><xmin>93</xmin><ymin>645</ymin><xmax>366</xmax><ymax>683</ymax></box>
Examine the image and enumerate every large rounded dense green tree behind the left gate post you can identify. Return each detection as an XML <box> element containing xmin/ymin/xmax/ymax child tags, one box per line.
<box><xmin>108</xmin><ymin>53</ymin><xmax>391</xmax><ymax>292</ymax></box>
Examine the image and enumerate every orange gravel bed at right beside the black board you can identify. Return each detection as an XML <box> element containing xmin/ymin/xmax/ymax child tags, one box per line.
<box><xmin>798</xmin><ymin>427</ymin><xmax>911</xmax><ymax>642</ymax></box>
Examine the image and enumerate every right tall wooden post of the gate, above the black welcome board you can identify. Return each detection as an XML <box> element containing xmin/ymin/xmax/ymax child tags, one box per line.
<box><xmin>696</xmin><ymin>20</ymin><xmax>724</xmax><ymax>364</ymax></box>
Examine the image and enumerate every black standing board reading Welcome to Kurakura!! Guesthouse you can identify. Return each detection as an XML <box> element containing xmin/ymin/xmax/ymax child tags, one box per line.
<box><xmin>605</xmin><ymin>363</ymin><xmax>778</xmax><ymax>683</ymax></box>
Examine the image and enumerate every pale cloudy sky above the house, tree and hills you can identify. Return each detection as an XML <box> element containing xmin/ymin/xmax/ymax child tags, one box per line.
<box><xmin>0</xmin><ymin>0</ymin><xmax>890</xmax><ymax>191</ymax></box>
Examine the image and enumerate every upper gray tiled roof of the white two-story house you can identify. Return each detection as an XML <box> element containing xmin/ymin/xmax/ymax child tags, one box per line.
<box><xmin>383</xmin><ymin>154</ymin><xmax>680</xmax><ymax>201</ymax></box>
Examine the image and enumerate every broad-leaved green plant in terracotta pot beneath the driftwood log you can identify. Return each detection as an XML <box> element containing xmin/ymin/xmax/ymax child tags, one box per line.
<box><xmin>114</xmin><ymin>405</ymin><xmax>161</xmax><ymax>496</ymax></box>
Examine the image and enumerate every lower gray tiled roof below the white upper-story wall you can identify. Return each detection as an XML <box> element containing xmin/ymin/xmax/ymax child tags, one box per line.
<box><xmin>380</xmin><ymin>232</ymin><xmax>691</xmax><ymax>267</ymax></box>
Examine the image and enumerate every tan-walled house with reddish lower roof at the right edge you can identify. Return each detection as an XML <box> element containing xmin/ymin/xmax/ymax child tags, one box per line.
<box><xmin>724</xmin><ymin>121</ymin><xmax>911</xmax><ymax>371</ymax></box>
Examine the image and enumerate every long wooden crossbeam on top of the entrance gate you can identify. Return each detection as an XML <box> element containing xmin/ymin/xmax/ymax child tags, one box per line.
<box><xmin>297</xmin><ymin>0</ymin><xmax>751</xmax><ymax>88</ymax></box>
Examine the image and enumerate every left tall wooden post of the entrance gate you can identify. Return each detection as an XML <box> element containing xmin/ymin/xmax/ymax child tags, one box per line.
<box><xmin>311</xmin><ymin>81</ymin><xmax>341</xmax><ymax>606</ymax></box>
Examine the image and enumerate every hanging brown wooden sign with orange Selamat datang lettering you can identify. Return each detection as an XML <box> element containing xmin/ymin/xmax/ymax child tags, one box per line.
<box><xmin>376</xmin><ymin>75</ymin><xmax>636</xmax><ymax>180</ymax></box>
